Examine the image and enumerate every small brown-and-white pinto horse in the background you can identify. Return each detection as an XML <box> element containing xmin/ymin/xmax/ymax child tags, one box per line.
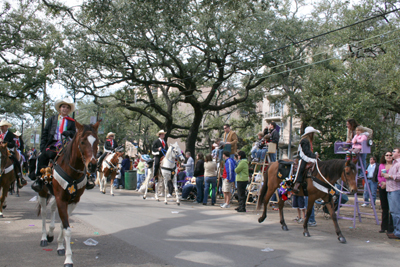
<box><xmin>96</xmin><ymin>152</ymin><xmax>124</xmax><ymax>196</ymax></box>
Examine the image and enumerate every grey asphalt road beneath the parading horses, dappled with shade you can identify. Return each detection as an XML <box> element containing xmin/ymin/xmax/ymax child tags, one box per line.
<box><xmin>0</xmin><ymin>181</ymin><xmax>400</xmax><ymax>267</ymax></box>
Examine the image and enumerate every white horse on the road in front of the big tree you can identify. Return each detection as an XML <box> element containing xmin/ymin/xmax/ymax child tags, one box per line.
<box><xmin>159</xmin><ymin>142</ymin><xmax>185</xmax><ymax>206</ymax></box>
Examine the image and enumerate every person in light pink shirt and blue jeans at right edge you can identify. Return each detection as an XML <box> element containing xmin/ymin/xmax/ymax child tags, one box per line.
<box><xmin>382</xmin><ymin>147</ymin><xmax>400</xmax><ymax>239</ymax></box>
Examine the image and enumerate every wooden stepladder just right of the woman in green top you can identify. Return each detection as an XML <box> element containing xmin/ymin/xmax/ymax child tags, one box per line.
<box><xmin>246</xmin><ymin>151</ymin><xmax>272</xmax><ymax>206</ymax></box>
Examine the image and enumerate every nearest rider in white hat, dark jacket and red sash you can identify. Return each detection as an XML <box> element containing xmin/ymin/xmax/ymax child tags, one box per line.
<box><xmin>30</xmin><ymin>98</ymin><xmax>94</xmax><ymax>192</ymax></box>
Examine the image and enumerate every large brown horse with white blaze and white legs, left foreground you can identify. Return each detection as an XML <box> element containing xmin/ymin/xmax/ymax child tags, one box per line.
<box><xmin>37</xmin><ymin>121</ymin><xmax>100</xmax><ymax>267</ymax></box>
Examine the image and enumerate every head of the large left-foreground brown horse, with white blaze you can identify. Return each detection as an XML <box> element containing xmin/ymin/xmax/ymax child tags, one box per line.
<box><xmin>75</xmin><ymin>121</ymin><xmax>100</xmax><ymax>173</ymax></box>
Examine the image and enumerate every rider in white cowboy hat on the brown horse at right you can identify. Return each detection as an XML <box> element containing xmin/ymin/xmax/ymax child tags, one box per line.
<box><xmin>293</xmin><ymin>126</ymin><xmax>320</xmax><ymax>193</ymax></box>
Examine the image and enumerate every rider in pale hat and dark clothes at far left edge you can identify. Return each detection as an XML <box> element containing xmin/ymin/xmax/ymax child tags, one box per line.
<box><xmin>0</xmin><ymin>120</ymin><xmax>27</xmax><ymax>188</ymax></box>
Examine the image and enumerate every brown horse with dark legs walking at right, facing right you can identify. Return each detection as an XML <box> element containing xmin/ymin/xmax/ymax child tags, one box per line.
<box><xmin>257</xmin><ymin>159</ymin><xmax>357</xmax><ymax>243</ymax></box>
